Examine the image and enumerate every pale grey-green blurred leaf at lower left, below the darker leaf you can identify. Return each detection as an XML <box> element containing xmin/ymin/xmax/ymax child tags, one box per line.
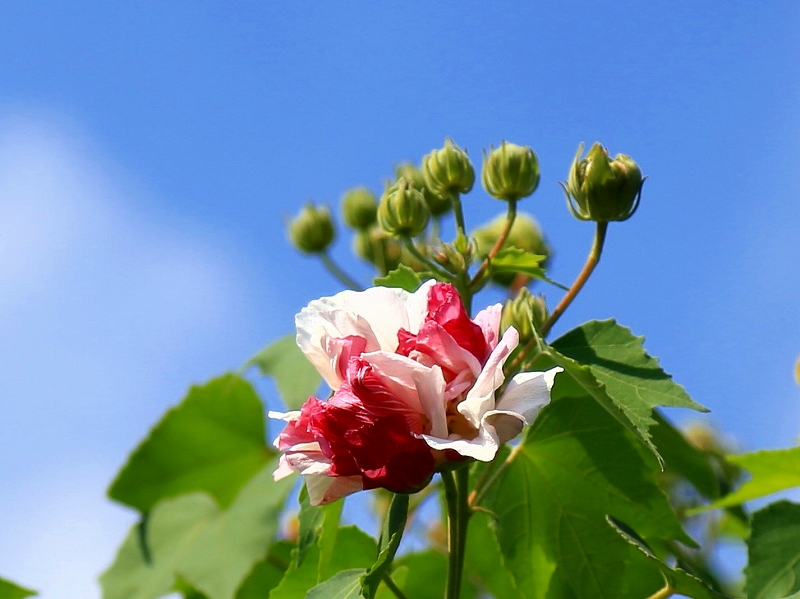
<box><xmin>100</xmin><ymin>458</ymin><xmax>293</xmax><ymax>599</ymax></box>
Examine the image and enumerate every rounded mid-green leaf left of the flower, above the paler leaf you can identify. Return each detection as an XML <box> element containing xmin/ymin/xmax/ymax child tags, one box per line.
<box><xmin>108</xmin><ymin>374</ymin><xmax>273</xmax><ymax>512</ymax></box>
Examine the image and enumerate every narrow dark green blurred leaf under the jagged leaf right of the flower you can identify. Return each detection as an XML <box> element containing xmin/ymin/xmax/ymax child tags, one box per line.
<box><xmin>650</xmin><ymin>410</ymin><xmax>719</xmax><ymax>499</ymax></box>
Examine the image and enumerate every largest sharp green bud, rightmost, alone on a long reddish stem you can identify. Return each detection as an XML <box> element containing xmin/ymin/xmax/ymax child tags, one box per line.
<box><xmin>561</xmin><ymin>143</ymin><xmax>644</xmax><ymax>222</ymax></box>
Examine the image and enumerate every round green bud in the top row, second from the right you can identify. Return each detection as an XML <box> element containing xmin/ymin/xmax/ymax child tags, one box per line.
<box><xmin>482</xmin><ymin>141</ymin><xmax>539</xmax><ymax>200</ymax></box>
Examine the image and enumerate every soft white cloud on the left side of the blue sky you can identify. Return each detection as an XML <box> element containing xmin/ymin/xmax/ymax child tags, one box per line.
<box><xmin>0</xmin><ymin>115</ymin><xmax>262</xmax><ymax>599</ymax></box>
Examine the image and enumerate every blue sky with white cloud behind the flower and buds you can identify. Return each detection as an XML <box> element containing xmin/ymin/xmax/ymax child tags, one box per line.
<box><xmin>0</xmin><ymin>0</ymin><xmax>800</xmax><ymax>599</ymax></box>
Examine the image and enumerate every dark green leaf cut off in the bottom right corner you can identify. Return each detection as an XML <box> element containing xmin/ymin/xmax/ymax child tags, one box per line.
<box><xmin>744</xmin><ymin>501</ymin><xmax>800</xmax><ymax>599</ymax></box>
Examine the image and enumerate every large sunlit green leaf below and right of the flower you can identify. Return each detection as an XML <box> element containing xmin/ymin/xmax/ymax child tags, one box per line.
<box><xmin>486</xmin><ymin>396</ymin><xmax>693</xmax><ymax>599</ymax></box>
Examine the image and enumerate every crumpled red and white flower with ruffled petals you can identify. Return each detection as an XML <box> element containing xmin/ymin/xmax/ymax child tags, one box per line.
<box><xmin>269</xmin><ymin>281</ymin><xmax>560</xmax><ymax>505</ymax></box>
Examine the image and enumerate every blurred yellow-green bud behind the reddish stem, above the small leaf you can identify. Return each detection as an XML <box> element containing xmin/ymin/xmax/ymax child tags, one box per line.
<box><xmin>472</xmin><ymin>212</ymin><xmax>552</xmax><ymax>287</ymax></box>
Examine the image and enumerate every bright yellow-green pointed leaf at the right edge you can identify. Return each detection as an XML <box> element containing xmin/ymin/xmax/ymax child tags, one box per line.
<box><xmin>708</xmin><ymin>447</ymin><xmax>800</xmax><ymax>508</ymax></box>
